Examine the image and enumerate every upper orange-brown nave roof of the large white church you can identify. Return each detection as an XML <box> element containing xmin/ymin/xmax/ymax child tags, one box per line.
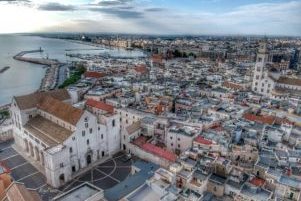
<box><xmin>38</xmin><ymin>96</ymin><xmax>84</xmax><ymax>125</ymax></box>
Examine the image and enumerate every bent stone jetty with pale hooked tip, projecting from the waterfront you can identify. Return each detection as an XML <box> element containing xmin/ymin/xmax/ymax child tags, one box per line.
<box><xmin>13</xmin><ymin>48</ymin><xmax>63</xmax><ymax>91</ymax></box>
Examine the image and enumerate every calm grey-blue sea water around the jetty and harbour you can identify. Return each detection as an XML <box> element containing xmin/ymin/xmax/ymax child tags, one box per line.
<box><xmin>0</xmin><ymin>35</ymin><xmax>143</xmax><ymax>105</ymax></box>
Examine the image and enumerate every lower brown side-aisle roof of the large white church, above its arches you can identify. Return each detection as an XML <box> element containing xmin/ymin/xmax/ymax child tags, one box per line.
<box><xmin>24</xmin><ymin>115</ymin><xmax>72</xmax><ymax>147</ymax></box>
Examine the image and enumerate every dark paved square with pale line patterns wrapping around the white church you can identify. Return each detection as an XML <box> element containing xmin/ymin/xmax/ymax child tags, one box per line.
<box><xmin>0</xmin><ymin>141</ymin><xmax>131</xmax><ymax>200</ymax></box>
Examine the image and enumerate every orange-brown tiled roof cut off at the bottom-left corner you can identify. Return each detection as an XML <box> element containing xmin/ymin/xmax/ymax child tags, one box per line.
<box><xmin>4</xmin><ymin>182</ymin><xmax>42</xmax><ymax>201</ymax></box>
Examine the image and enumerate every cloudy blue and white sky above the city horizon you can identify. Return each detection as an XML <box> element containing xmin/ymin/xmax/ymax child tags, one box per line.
<box><xmin>0</xmin><ymin>0</ymin><xmax>301</xmax><ymax>36</ymax></box>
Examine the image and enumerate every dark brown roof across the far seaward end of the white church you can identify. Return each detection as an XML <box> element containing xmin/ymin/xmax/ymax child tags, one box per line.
<box><xmin>14</xmin><ymin>89</ymin><xmax>70</xmax><ymax>110</ymax></box>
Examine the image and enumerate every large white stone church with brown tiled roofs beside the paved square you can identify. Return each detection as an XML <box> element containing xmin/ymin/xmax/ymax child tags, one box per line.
<box><xmin>11</xmin><ymin>89</ymin><xmax>120</xmax><ymax>187</ymax></box>
